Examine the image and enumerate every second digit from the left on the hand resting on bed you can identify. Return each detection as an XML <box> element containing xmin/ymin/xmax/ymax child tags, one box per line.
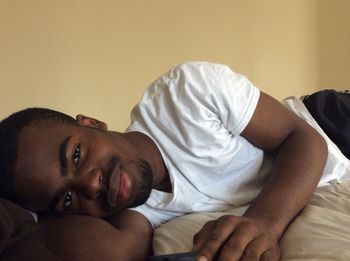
<box><xmin>198</xmin><ymin>216</ymin><xmax>239</xmax><ymax>260</ymax></box>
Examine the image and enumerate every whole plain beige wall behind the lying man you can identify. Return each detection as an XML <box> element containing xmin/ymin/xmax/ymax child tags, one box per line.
<box><xmin>0</xmin><ymin>0</ymin><xmax>350</xmax><ymax>130</ymax></box>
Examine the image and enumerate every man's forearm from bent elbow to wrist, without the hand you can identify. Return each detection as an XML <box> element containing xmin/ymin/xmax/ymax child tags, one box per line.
<box><xmin>244</xmin><ymin>123</ymin><xmax>327</xmax><ymax>239</ymax></box>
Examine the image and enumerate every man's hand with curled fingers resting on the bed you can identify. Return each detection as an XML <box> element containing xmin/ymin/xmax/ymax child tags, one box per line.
<box><xmin>193</xmin><ymin>215</ymin><xmax>280</xmax><ymax>261</ymax></box>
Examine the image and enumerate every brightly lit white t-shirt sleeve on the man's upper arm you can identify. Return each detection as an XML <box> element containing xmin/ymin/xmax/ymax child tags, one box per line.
<box><xmin>170</xmin><ymin>62</ymin><xmax>260</xmax><ymax>135</ymax></box>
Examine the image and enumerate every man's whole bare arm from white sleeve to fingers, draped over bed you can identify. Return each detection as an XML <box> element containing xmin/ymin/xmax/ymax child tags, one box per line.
<box><xmin>194</xmin><ymin>93</ymin><xmax>327</xmax><ymax>260</ymax></box>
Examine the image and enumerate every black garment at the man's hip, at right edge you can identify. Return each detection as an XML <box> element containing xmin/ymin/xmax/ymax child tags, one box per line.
<box><xmin>303</xmin><ymin>90</ymin><xmax>350</xmax><ymax>159</ymax></box>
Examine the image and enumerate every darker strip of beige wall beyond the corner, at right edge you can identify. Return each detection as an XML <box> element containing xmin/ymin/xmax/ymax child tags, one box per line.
<box><xmin>318</xmin><ymin>0</ymin><xmax>350</xmax><ymax>89</ymax></box>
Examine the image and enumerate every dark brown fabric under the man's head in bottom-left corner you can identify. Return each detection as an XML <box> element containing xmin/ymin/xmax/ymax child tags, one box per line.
<box><xmin>0</xmin><ymin>198</ymin><xmax>59</xmax><ymax>260</ymax></box>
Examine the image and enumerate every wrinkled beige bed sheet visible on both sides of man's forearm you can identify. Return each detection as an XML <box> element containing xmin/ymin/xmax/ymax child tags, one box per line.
<box><xmin>153</xmin><ymin>182</ymin><xmax>350</xmax><ymax>261</ymax></box>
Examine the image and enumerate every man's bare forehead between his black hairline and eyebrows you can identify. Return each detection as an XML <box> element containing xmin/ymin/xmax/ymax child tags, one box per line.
<box><xmin>14</xmin><ymin>122</ymin><xmax>69</xmax><ymax>207</ymax></box>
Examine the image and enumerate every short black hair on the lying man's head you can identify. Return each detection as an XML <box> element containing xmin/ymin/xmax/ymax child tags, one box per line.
<box><xmin>0</xmin><ymin>108</ymin><xmax>76</xmax><ymax>202</ymax></box>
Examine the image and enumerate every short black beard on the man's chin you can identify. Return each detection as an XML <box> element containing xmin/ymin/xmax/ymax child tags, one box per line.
<box><xmin>130</xmin><ymin>156</ymin><xmax>153</xmax><ymax>208</ymax></box>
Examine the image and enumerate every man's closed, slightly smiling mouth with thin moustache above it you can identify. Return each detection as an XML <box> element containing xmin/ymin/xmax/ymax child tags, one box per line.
<box><xmin>107</xmin><ymin>160</ymin><xmax>131</xmax><ymax>208</ymax></box>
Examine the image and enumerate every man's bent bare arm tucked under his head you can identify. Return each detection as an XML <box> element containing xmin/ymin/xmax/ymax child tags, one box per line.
<box><xmin>42</xmin><ymin>210</ymin><xmax>153</xmax><ymax>261</ymax></box>
